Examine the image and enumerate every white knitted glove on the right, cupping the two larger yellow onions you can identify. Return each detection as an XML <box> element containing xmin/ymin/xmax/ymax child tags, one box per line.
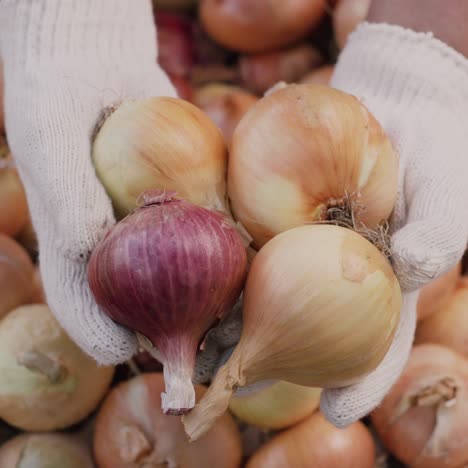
<box><xmin>321</xmin><ymin>23</ymin><xmax>468</xmax><ymax>426</ymax></box>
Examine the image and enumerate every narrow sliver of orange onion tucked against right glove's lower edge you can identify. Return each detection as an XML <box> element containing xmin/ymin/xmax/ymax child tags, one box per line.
<box><xmin>417</xmin><ymin>262</ymin><xmax>462</xmax><ymax>320</ymax></box>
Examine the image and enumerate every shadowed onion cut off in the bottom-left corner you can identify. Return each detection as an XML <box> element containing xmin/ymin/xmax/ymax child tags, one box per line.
<box><xmin>0</xmin><ymin>433</ymin><xmax>94</xmax><ymax>468</ymax></box>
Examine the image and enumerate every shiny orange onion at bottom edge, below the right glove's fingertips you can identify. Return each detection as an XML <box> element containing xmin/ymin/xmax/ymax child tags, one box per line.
<box><xmin>246</xmin><ymin>413</ymin><xmax>375</xmax><ymax>468</ymax></box>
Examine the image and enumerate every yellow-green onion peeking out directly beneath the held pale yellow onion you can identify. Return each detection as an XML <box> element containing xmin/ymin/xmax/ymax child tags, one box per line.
<box><xmin>229</xmin><ymin>381</ymin><xmax>321</xmax><ymax>429</ymax></box>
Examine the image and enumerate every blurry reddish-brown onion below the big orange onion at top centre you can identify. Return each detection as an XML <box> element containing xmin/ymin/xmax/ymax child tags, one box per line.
<box><xmin>239</xmin><ymin>44</ymin><xmax>323</xmax><ymax>94</ymax></box>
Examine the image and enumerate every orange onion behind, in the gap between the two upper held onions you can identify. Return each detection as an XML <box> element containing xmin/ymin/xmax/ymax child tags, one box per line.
<box><xmin>192</xmin><ymin>83</ymin><xmax>258</xmax><ymax>148</ymax></box>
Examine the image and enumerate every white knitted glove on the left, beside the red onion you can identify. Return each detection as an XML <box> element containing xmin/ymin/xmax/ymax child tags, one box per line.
<box><xmin>0</xmin><ymin>0</ymin><xmax>176</xmax><ymax>364</ymax></box>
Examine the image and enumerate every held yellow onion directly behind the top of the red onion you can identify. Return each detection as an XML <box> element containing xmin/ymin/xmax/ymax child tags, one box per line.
<box><xmin>93</xmin><ymin>97</ymin><xmax>227</xmax><ymax>218</ymax></box>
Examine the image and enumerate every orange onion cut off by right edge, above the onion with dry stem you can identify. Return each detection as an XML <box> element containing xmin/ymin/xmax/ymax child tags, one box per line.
<box><xmin>415</xmin><ymin>277</ymin><xmax>468</xmax><ymax>357</ymax></box>
